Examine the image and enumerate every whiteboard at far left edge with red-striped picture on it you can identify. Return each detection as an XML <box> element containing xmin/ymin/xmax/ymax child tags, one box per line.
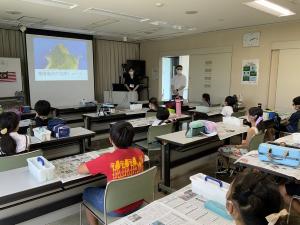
<box><xmin>0</xmin><ymin>57</ymin><xmax>22</xmax><ymax>98</ymax></box>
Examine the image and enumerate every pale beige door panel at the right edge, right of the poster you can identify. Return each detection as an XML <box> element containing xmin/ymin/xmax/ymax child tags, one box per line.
<box><xmin>275</xmin><ymin>49</ymin><xmax>300</xmax><ymax>112</ymax></box>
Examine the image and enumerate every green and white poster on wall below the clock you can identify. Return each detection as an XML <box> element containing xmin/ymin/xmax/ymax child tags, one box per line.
<box><xmin>242</xmin><ymin>59</ymin><xmax>259</xmax><ymax>84</ymax></box>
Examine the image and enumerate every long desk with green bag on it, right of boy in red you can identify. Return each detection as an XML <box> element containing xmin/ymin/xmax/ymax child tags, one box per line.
<box><xmin>156</xmin><ymin>122</ymin><xmax>249</xmax><ymax>192</ymax></box>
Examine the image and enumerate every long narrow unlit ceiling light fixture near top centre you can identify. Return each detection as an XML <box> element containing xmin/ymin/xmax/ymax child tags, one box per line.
<box><xmin>84</xmin><ymin>8</ymin><xmax>149</xmax><ymax>22</ymax></box>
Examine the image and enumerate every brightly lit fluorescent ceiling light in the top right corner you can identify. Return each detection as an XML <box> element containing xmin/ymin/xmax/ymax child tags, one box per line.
<box><xmin>244</xmin><ymin>0</ymin><xmax>296</xmax><ymax>17</ymax></box>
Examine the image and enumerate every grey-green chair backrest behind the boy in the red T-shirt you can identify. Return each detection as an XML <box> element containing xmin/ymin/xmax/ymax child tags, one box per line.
<box><xmin>104</xmin><ymin>166</ymin><xmax>157</xmax><ymax>224</ymax></box>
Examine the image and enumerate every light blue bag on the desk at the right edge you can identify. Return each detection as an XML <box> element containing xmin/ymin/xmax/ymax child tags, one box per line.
<box><xmin>258</xmin><ymin>143</ymin><xmax>300</xmax><ymax>167</ymax></box>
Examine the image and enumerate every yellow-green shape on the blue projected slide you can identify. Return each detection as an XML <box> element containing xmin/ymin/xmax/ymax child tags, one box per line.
<box><xmin>46</xmin><ymin>44</ymin><xmax>79</xmax><ymax>70</ymax></box>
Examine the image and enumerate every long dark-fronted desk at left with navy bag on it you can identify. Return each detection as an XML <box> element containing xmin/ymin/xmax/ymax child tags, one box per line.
<box><xmin>29</xmin><ymin>127</ymin><xmax>95</xmax><ymax>159</ymax></box>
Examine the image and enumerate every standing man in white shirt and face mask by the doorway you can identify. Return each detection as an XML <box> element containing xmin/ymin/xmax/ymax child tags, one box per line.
<box><xmin>171</xmin><ymin>65</ymin><xmax>186</xmax><ymax>99</ymax></box>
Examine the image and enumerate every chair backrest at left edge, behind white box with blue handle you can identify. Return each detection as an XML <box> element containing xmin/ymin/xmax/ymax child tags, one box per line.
<box><xmin>0</xmin><ymin>150</ymin><xmax>43</xmax><ymax>172</ymax></box>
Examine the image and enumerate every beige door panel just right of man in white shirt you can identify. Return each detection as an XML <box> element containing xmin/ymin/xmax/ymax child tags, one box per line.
<box><xmin>189</xmin><ymin>53</ymin><xmax>231</xmax><ymax>104</ymax></box>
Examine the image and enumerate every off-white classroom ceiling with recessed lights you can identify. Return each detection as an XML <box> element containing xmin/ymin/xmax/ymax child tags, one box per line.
<box><xmin>0</xmin><ymin>0</ymin><xmax>300</xmax><ymax>41</ymax></box>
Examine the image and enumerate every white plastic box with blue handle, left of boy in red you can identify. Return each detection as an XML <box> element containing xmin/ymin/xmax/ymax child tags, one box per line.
<box><xmin>27</xmin><ymin>156</ymin><xmax>55</xmax><ymax>182</ymax></box>
